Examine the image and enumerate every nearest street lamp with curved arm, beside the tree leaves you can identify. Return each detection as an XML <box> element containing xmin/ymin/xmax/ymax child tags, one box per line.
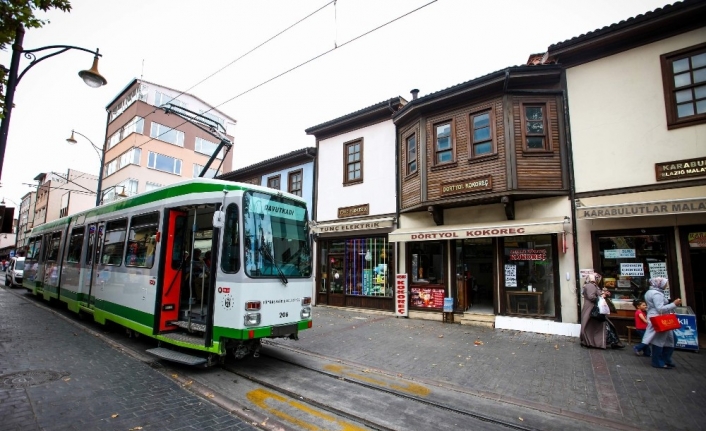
<box><xmin>0</xmin><ymin>25</ymin><xmax>108</xmax><ymax>184</ymax></box>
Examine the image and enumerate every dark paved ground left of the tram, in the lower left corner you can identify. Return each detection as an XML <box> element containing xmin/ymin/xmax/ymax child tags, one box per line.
<box><xmin>0</xmin><ymin>288</ymin><xmax>256</xmax><ymax>431</ymax></box>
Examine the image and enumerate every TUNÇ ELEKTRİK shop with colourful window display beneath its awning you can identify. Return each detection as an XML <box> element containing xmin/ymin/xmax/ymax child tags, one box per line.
<box><xmin>312</xmin><ymin>217</ymin><xmax>395</xmax><ymax>311</ymax></box>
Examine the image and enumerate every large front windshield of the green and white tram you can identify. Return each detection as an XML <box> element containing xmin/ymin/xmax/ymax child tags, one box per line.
<box><xmin>243</xmin><ymin>191</ymin><xmax>311</xmax><ymax>278</ymax></box>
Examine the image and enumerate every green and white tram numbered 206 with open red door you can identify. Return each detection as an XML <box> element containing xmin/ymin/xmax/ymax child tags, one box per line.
<box><xmin>23</xmin><ymin>178</ymin><xmax>312</xmax><ymax>365</ymax></box>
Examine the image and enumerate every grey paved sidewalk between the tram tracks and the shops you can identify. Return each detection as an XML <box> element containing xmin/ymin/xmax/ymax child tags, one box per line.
<box><xmin>278</xmin><ymin>306</ymin><xmax>706</xmax><ymax>430</ymax></box>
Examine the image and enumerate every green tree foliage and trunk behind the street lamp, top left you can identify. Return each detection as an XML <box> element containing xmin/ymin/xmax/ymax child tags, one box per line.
<box><xmin>0</xmin><ymin>0</ymin><xmax>71</xmax><ymax>118</ymax></box>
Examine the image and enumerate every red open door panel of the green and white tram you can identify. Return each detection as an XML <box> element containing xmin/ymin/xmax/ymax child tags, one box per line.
<box><xmin>159</xmin><ymin>210</ymin><xmax>187</xmax><ymax>331</ymax></box>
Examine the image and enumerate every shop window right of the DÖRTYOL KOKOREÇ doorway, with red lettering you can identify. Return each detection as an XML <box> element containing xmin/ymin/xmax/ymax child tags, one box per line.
<box><xmin>500</xmin><ymin>235</ymin><xmax>558</xmax><ymax>316</ymax></box>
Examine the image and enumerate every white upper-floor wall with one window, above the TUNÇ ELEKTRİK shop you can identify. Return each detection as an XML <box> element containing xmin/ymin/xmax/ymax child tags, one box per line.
<box><xmin>316</xmin><ymin>120</ymin><xmax>397</xmax><ymax>222</ymax></box>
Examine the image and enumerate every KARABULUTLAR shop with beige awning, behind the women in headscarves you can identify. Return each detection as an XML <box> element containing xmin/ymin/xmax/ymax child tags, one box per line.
<box><xmin>577</xmin><ymin>192</ymin><xmax>706</xmax><ymax>334</ymax></box>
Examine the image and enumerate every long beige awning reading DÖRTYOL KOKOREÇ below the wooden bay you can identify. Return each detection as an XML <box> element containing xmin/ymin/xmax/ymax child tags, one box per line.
<box><xmin>389</xmin><ymin>217</ymin><xmax>571</xmax><ymax>242</ymax></box>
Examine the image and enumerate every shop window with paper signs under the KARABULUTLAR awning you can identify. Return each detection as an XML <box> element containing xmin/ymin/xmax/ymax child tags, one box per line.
<box><xmin>594</xmin><ymin>232</ymin><xmax>669</xmax><ymax>304</ymax></box>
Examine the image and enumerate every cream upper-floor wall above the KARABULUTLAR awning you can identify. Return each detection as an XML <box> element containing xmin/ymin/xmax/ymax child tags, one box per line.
<box><xmin>566</xmin><ymin>28</ymin><xmax>706</xmax><ymax>193</ymax></box>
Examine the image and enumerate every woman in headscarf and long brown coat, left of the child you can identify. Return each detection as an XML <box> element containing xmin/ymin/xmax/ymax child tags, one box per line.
<box><xmin>581</xmin><ymin>273</ymin><xmax>625</xmax><ymax>349</ymax></box>
